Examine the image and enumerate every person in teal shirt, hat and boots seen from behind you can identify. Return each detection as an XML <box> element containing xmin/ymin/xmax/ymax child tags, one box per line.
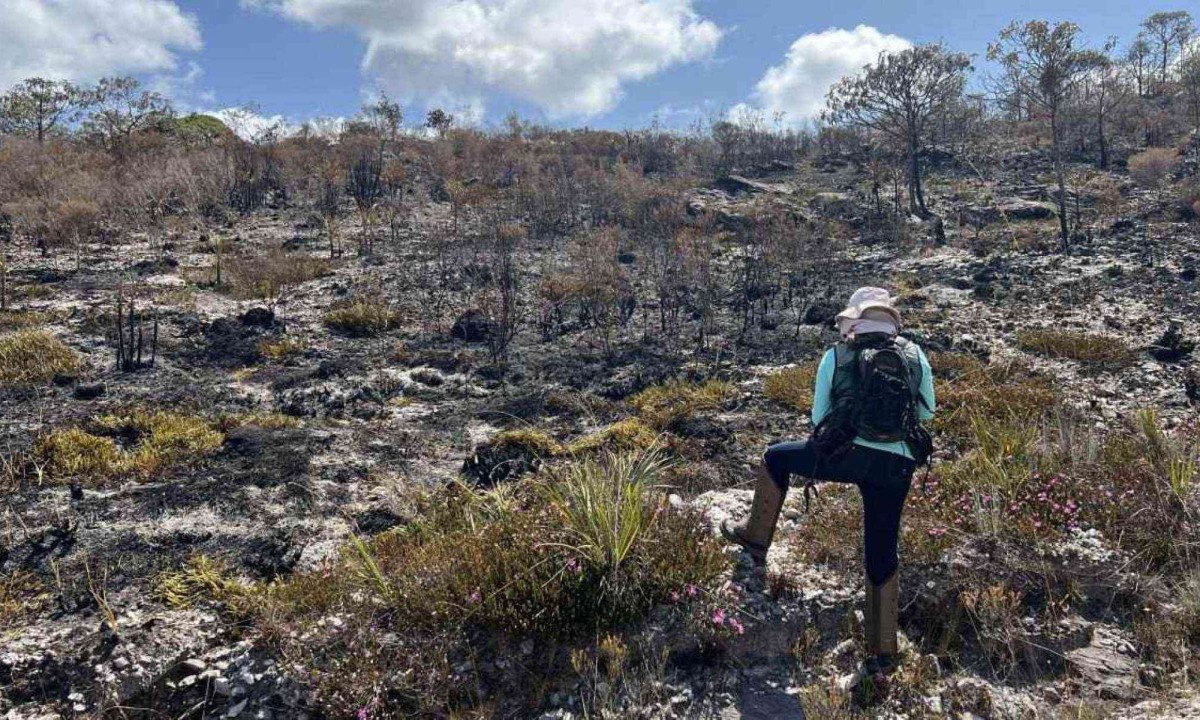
<box><xmin>721</xmin><ymin>287</ymin><xmax>936</xmax><ymax>674</ymax></box>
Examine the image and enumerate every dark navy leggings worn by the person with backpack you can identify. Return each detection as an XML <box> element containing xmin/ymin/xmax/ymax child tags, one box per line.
<box><xmin>763</xmin><ymin>440</ymin><xmax>917</xmax><ymax>584</ymax></box>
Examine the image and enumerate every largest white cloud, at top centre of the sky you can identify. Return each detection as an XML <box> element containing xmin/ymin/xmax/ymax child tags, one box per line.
<box><xmin>244</xmin><ymin>0</ymin><xmax>721</xmax><ymax>116</ymax></box>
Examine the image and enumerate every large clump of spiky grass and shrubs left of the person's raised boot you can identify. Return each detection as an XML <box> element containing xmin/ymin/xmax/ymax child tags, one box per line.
<box><xmin>256</xmin><ymin>454</ymin><xmax>726</xmax><ymax>716</ymax></box>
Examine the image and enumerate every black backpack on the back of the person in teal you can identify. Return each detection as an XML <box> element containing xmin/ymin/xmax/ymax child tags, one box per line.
<box><xmin>814</xmin><ymin>336</ymin><xmax>932</xmax><ymax>463</ymax></box>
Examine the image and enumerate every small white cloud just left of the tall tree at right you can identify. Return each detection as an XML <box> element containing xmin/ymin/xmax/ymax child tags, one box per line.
<box><xmin>731</xmin><ymin>25</ymin><xmax>912</xmax><ymax>125</ymax></box>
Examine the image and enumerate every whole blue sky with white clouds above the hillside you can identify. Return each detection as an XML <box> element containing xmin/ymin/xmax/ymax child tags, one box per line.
<box><xmin>0</xmin><ymin>0</ymin><xmax>1178</xmax><ymax>128</ymax></box>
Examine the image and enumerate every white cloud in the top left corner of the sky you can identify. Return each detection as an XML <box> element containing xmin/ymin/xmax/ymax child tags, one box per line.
<box><xmin>0</xmin><ymin>0</ymin><xmax>202</xmax><ymax>89</ymax></box>
